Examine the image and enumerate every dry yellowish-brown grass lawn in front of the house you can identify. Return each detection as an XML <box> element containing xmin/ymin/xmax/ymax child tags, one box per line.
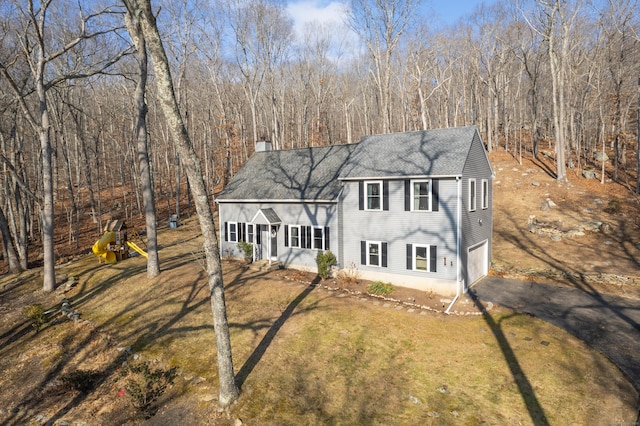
<box><xmin>0</xmin><ymin>221</ymin><xmax>638</xmax><ymax>424</ymax></box>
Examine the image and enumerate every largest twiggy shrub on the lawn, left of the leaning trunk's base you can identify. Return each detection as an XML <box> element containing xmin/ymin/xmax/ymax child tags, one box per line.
<box><xmin>121</xmin><ymin>362</ymin><xmax>177</xmax><ymax>419</ymax></box>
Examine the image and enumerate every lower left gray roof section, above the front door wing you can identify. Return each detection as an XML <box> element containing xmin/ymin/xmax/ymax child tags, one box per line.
<box><xmin>217</xmin><ymin>144</ymin><xmax>356</xmax><ymax>201</ymax></box>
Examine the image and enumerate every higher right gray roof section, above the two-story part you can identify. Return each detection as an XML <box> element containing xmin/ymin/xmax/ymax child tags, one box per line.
<box><xmin>340</xmin><ymin>126</ymin><xmax>477</xmax><ymax>180</ymax></box>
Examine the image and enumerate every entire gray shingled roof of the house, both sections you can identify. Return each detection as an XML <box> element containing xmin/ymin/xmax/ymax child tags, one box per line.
<box><xmin>217</xmin><ymin>126</ymin><xmax>477</xmax><ymax>202</ymax></box>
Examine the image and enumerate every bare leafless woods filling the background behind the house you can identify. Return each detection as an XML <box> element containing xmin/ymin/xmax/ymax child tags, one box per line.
<box><xmin>0</xmin><ymin>0</ymin><xmax>640</xmax><ymax>269</ymax></box>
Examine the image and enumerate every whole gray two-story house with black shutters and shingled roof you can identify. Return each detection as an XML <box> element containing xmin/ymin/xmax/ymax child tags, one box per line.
<box><xmin>216</xmin><ymin>127</ymin><xmax>493</xmax><ymax>295</ymax></box>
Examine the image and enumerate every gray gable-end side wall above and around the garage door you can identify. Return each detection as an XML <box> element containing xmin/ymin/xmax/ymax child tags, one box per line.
<box><xmin>460</xmin><ymin>133</ymin><xmax>493</xmax><ymax>290</ymax></box>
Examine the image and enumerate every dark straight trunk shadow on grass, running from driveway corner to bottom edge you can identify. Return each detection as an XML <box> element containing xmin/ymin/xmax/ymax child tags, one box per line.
<box><xmin>468</xmin><ymin>291</ymin><xmax>549</xmax><ymax>425</ymax></box>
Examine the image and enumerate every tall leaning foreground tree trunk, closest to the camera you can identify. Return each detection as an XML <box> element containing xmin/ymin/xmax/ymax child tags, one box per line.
<box><xmin>123</xmin><ymin>0</ymin><xmax>239</xmax><ymax>407</ymax></box>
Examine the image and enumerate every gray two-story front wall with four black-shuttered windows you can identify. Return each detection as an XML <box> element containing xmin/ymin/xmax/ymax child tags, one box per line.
<box><xmin>340</xmin><ymin>178</ymin><xmax>458</xmax><ymax>294</ymax></box>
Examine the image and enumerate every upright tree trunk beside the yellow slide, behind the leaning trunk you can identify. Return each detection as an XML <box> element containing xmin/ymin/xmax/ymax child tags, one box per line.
<box><xmin>127</xmin><ymin>7</ymin><xmax>160</xmax><ymax>278</ymax></box>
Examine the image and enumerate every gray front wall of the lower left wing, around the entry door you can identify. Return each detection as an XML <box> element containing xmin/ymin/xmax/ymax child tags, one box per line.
<box><xmin>218</xmin><ymin>202</ymin><xmax>340</xmax><ymax>270</ymax></box>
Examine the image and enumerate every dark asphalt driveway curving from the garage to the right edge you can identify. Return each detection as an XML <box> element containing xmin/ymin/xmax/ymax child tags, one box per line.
<box><xmin>470</xmin><ymin>277</ymin><xmax>640</xmax><ymax>392</ymax></box>
